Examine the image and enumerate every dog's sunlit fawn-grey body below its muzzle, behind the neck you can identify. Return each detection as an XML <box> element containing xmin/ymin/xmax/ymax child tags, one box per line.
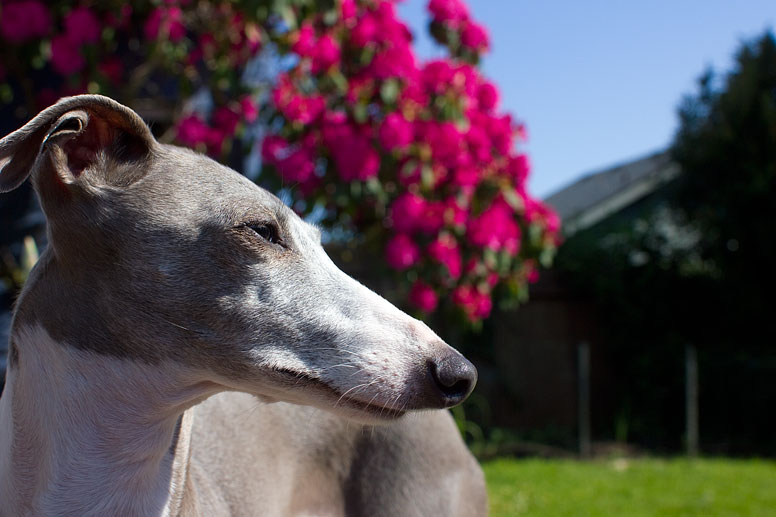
<box><xmin>192</xmin><ymin>393</ymin><xmax>487</xmax><ymax>516</ymax></box>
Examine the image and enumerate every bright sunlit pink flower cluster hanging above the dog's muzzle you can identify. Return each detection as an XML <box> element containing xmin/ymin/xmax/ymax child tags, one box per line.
<box><xmin>262</xmin><ymin>0</ymin><xmax>559</xmax><ymax>321</ymax></box>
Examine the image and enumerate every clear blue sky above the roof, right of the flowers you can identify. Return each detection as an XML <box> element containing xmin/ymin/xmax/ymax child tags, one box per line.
<box><xmin>399</xmin><ymin>0</ymin><xmax>776</xmax><ymax>197</ymax></box>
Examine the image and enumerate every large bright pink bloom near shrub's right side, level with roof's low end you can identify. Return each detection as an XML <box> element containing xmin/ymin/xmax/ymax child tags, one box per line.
<box><xmin>466</xmin><ymin>197</ymin><xmax>520</xmax><ymax>255</ymax></box>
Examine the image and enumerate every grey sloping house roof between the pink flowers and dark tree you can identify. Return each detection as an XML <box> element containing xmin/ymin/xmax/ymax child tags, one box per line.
<box><xmin>545</xmin><ymin>151</ymin><xmax>679</xmax><ymax>236</ymax></box>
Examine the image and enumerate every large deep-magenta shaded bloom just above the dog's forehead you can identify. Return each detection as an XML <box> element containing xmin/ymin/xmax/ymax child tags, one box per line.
<box><xmin>323</xmin><ymin>117</ymin><xmax>380</xmax><ymax>181</ymax></box>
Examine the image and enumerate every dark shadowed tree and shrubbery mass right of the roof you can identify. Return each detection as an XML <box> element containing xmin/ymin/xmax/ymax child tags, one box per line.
<box><xmin>557</xmin><ymin>32</ymin><xmax>776</xmax><ymax>454</ymax></box>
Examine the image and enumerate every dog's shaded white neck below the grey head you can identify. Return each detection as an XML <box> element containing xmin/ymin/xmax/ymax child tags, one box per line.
<box><xmin>0</xmin><ymin>325</ymin><xmax>214</xmax><ymax>515</ymax></box>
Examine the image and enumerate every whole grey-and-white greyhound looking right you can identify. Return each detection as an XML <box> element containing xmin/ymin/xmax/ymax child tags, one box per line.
<box><xmin>0</xmin><ymin>95</ymin><xmax>487</xmax><ymax>516</ymax></box>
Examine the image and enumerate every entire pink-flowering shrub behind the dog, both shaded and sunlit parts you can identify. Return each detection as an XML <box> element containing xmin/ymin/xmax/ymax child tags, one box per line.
<box><xmin>0</xmin><ymin>0</ymin><xmax>559</xmax><ymax>322</ymax></box>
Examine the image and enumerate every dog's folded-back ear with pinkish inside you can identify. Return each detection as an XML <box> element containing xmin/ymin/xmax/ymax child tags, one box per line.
<box><xmin>0</xmin><ymin>95</ymin><xmax>158</xmax><ymax>197</ymax></box>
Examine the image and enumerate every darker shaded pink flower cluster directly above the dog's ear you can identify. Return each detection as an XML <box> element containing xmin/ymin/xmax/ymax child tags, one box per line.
<box><xmin>0</xmin><ymin>0</ymin><xmax>264</xmax><ymax>144</ymax></box>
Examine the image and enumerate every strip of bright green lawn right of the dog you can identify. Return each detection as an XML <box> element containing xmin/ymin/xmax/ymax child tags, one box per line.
<box><xmin>483</xmin><ymin>459</ymin><xmax>776</xmax><ymax>517</ymax></box>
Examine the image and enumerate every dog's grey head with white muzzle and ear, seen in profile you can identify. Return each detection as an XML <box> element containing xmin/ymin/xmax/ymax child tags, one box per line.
<box><xmin>0</xmin><ymin>95</ymin><xmax>476</xmax><ymax>419</ymax></box>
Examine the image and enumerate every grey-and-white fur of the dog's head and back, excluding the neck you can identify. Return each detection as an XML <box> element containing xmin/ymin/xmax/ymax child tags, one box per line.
<box><xmin>0</xmin><ymin>95</ymin><xmax>487</xmax><ymax>516</ymax></box>
